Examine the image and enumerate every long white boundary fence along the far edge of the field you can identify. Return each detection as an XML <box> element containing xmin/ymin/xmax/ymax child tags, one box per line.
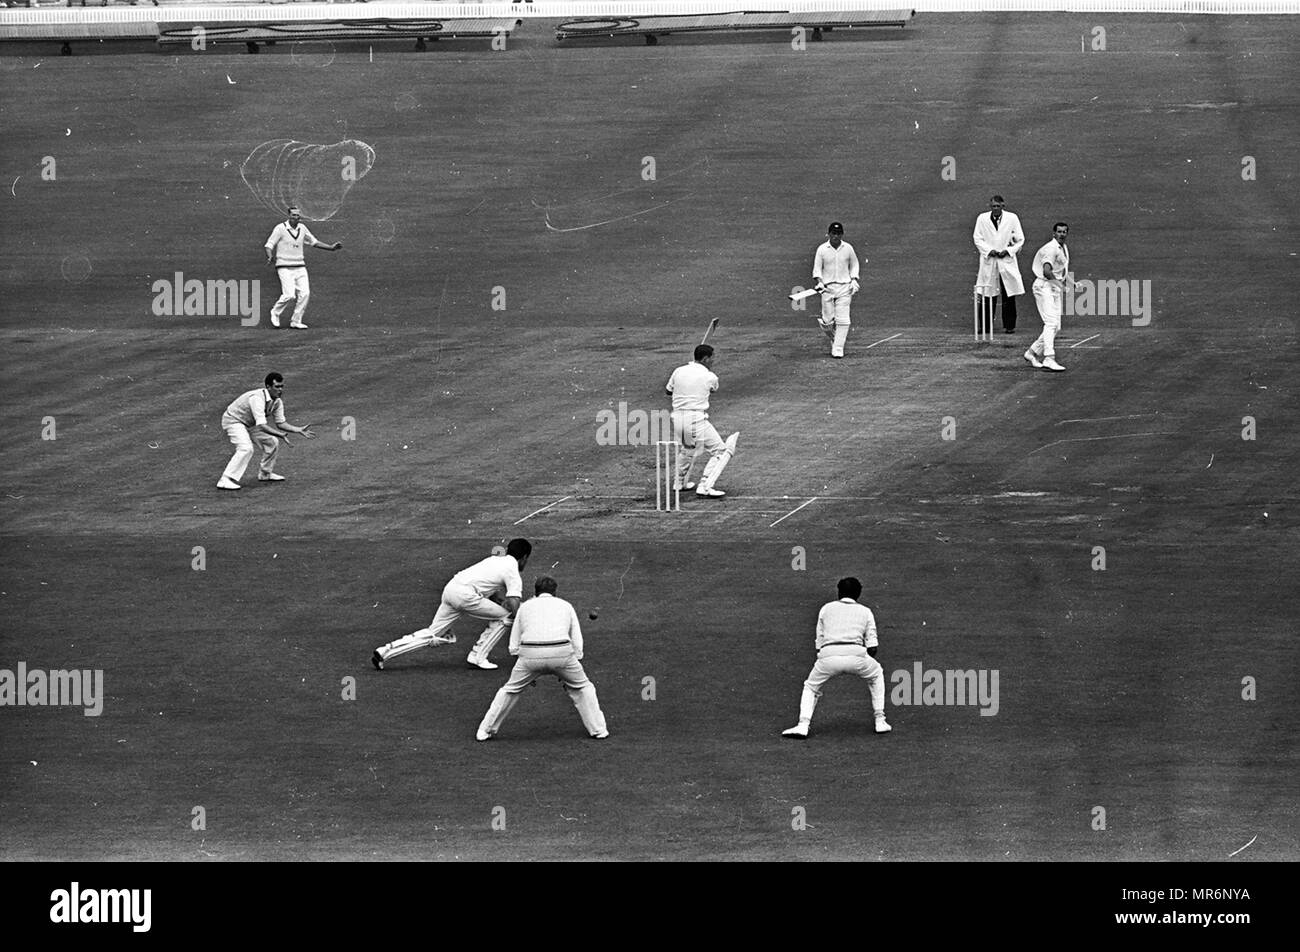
<box><xmin>0</xmin><ymin>0</ymin><xmax>1300</xmax><ymax>23</ymax></box>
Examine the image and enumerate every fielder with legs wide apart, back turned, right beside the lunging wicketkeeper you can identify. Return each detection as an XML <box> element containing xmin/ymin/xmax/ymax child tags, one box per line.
<box><xmin>475</xmin><ymin>575</ymin><xmax>610</xmax><ymax>740</ymax></box>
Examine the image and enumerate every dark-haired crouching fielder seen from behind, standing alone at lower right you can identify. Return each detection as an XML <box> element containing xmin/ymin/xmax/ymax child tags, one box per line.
<box><xmin>781</xmin><ymin>579</ymin><xmax>893</xmax><ymax>739</ymax></box>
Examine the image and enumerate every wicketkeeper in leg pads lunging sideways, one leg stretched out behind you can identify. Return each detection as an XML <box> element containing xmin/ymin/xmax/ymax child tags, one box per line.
<box><xmin>371</xmin><ymin>538</ymin><xmax>533</xmax><ymax>671</ymax></box>
